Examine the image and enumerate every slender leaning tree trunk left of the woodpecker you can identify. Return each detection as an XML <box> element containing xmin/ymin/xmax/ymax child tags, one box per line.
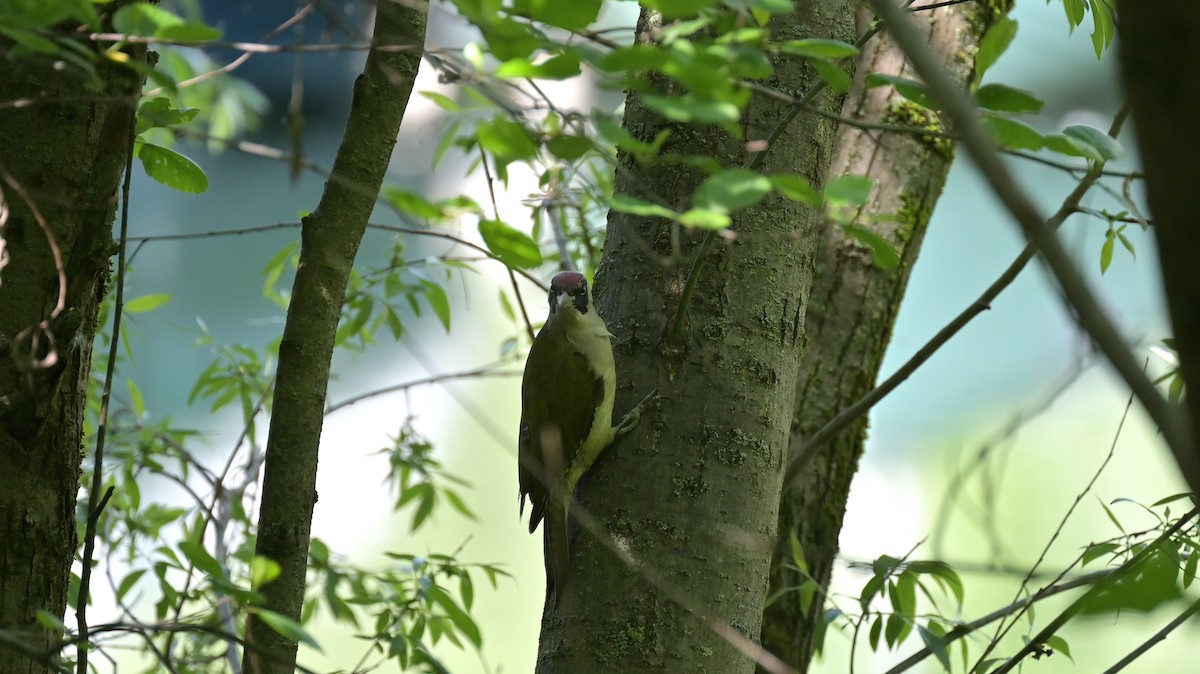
<box><xmin>242</xmin><ymin>0</ymin><xmax>428</xmax><ymax>674</ymax></box>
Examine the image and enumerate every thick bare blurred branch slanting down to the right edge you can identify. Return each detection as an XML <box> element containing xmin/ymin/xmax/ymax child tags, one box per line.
<box><xmin>869</xmin><ymin>0</ymin><xmax>1200</xmax><ymax>492</ymax></box>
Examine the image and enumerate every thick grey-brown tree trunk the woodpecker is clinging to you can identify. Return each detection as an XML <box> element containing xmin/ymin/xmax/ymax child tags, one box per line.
<box><xmin>538</xmin><ymin>0</ymin><xmax>853</xmax><ymax>674</ymax></box>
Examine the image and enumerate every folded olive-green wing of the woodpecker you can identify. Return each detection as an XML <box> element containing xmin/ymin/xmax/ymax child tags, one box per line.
<box><xmin>517</xmin><ymin>324</ymin><xmax>605</xmax><ymax>532</ymax></box>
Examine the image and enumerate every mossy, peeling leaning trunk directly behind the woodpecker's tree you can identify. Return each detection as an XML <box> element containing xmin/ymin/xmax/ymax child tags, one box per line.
<box><xmin>762</xmin><ymin>4</ymin><xmax>1007</xmax><ymax>672</ymax></box>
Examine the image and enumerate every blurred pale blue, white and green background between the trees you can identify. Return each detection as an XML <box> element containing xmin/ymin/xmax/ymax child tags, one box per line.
<box><xmin>120</xmin><ymin>0</ymin><xmax>1200</xmax><ymax>673</ymax></box>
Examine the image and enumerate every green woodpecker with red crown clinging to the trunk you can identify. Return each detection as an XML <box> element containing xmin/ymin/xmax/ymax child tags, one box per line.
<box><xmin>517</xmin><ymin>271</ymin><xmax>617</xmax><ymax>601</ymax></box>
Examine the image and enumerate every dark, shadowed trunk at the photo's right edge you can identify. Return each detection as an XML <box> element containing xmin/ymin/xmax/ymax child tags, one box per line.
<box><xmin>1117</xmin><ymin>0</ymin><xmax>1200</xmax><ymax>488</ymax></box>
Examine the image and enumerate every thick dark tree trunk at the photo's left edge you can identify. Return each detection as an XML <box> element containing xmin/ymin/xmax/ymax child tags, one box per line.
<box><xmin>0</xmin><ymin>26</ymin><xmax>145</xmax><ymax>674</ymax></box>
